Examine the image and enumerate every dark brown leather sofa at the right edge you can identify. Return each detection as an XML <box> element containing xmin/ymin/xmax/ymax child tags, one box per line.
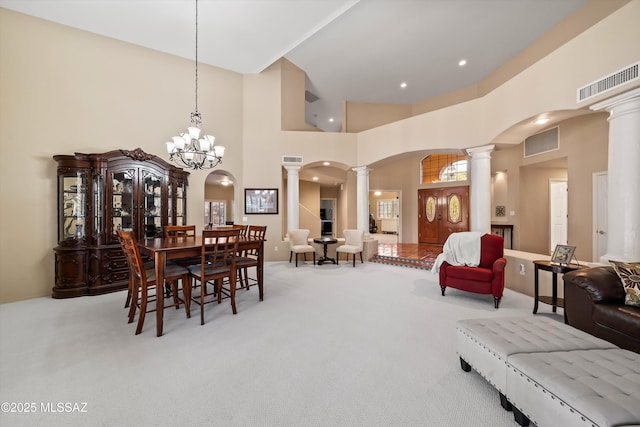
<box><xmin>563</xmin><ymin>267</ymin><xmax>640</xmax><ymax>353</ymax></box>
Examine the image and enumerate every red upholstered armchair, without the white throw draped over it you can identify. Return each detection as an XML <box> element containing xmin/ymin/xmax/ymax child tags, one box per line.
<box><xmin>440</xmin><ymin>234</ymin><xmax>507</xmax><ymax>308</ymax></box>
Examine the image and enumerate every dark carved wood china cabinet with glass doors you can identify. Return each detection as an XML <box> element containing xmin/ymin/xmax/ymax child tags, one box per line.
<box><xmin>52</xmin><ymin>148</ymin><xmax>189</xmax><ymax>298</ymax></box>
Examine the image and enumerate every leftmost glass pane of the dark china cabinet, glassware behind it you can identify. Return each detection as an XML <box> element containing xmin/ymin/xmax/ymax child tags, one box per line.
<box><xmin>58</xmin><ymin>172</ymin><xmax>87</xmax><ymax>241</ymax></box>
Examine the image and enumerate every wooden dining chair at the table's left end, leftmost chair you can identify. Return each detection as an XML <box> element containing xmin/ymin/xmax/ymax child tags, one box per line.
<box><xmin>117</xmin><ymin>230</ymin><xmax>191</xmax><ymax>335</ymax></box>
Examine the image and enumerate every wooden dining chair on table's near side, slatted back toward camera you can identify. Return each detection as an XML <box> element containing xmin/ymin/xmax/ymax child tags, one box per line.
<box><xmin>189</xmin><ymin>228</ymin><xmax>240</xmax><ymax>325</ymax></box>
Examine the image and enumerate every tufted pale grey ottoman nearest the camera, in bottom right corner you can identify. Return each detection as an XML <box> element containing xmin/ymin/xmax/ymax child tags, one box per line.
<box><xmin>507</xmin><ymin>349</ymin><xmax>640</xmax><ymax>427</ymax></box>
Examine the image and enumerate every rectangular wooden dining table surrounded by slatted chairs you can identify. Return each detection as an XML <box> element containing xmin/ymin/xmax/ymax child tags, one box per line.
<box><xmin>138</xmin><ymin>235</ymin><xmax>265</xmax><ymax>336</ymax></box>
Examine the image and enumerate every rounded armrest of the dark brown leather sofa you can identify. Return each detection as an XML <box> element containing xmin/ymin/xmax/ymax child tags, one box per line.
<box><xmin>563</xmin><ymin>267</ymin><xmax>625</xmax><ymax>304</ymax></box>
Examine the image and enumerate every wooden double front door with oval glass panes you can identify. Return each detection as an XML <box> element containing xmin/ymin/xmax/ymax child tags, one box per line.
<box><xmin>418</xmin><ymin>186</ymin><xmax>469</xmax><ymax>245</ymax></box>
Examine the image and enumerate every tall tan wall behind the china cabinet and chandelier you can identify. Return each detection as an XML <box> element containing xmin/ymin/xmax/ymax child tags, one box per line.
<box><xmin>0</xmin><ymin>9</ymin><xmax>243</xmax><ymax>302</ymax></box>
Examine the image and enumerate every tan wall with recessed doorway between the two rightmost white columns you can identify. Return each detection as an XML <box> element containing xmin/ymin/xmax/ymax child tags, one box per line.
<box><xmin>491</xmin><ymin>113</ymin><xmax>609</xmax><ymax>260</ymax></box>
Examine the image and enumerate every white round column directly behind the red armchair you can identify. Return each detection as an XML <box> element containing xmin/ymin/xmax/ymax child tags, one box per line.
<box><xmin>467</xmin><ymin>145</ymin><xmax>495</xmax><ymax>233</ymax></box>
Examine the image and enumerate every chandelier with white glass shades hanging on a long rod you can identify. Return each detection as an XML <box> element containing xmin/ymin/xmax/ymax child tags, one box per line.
<box><xmin>167</xmin><ymin>0</ymin><xmax>224</xmax><ymax>169</ymax></box>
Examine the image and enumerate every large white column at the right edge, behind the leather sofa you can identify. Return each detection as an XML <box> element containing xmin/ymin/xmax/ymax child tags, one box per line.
<box><xmin>591</xmin><ymin>88</ymin><xmax>640</xmax><ymax>263</ymax></box>
